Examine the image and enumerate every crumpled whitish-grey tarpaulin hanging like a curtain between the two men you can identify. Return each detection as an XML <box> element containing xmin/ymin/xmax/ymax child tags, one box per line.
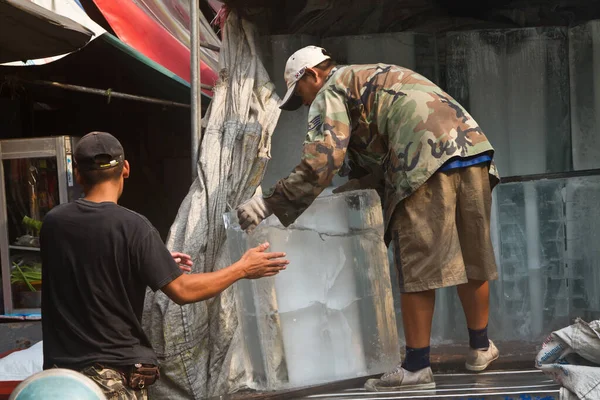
<box><xmin>143</xmin><ymin>12</ymin><xmax>280</xmax><ymax>399</ymax></box>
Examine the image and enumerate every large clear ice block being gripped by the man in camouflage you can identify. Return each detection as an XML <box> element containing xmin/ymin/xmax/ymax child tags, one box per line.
<box><xmin>225</xmin><ymin>190</ymin><xmax>400</xmax><ymax>389</ymax></box>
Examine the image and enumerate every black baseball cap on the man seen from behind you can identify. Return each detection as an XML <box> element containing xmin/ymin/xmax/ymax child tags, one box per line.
<box><xmin>73</xmin><ymin>132</ymin><xmax>125</xmax><ymax>170</ymax></box>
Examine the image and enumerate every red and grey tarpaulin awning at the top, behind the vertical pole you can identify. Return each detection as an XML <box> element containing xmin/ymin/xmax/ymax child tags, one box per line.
<box><xmin>94</xmin><ymin>0</ymin><xmax>220</xmax><ymax>94</ymax></box>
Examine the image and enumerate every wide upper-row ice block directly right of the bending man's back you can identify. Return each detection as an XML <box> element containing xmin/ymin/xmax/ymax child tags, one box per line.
<box><xmin>446</xmin><ymin>27</ymin><xmax>572</xmax><ymax>176</ymax></box>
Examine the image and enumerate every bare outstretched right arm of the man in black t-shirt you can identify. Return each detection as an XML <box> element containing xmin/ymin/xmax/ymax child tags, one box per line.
<box><xmin>161</xmin><ymin>243</ymin><xmax>289</xmax><ymax>305</ymax></box>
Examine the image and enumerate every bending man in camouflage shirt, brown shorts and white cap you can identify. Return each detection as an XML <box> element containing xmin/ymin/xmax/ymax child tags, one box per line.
<box><xmin>238</xmin><ymin>46</ymin><xmax>499</xmax><ymax>391</ymax></box>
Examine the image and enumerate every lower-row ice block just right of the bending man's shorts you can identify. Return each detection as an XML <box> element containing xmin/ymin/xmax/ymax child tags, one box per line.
<box><xmin>494</xmin><ymin>179</ymin><xmax>571</xmax><ymax>341</ymax></box>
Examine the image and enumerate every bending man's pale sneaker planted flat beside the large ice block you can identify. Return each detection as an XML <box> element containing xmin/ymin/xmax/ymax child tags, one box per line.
<box><xmin>365</xmin><ymin>365</ymin><xmax>435</xmax><ymax>392</ymax></box>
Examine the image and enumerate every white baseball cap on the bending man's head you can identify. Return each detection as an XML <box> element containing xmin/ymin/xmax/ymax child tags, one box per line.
<box><xmin>279</xmin><ymin>46</ymin><xmax>331</xmax><ymax>111</ymax></box>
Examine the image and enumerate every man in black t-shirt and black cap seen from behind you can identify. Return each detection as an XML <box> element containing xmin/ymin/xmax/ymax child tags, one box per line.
<box><xmin>40</xmin><ymin>132</ymin><xmax>288</xmax><ymax>399</ymax></box>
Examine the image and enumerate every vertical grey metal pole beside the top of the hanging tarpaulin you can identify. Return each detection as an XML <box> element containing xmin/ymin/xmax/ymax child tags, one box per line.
<box><xmin>190</xmin><ymin>0</ymin><xmax>202</xmax><ymax>181</ymax></box>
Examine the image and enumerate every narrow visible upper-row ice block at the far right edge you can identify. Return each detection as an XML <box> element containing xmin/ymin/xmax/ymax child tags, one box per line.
<box><xmin>569</xmin><ymin>20</ymin><xmax>600</xmax><ymax>170</ymax></box>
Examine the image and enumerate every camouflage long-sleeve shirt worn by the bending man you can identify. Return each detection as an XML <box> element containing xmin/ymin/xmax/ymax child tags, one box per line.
<box><xmin>265</xmin><ymin>64</ymin><xmax>497</xmax><ymax>229</ymax></box>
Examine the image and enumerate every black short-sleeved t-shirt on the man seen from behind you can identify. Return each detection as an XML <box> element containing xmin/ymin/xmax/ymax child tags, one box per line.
<box><xmin>40</xmin><ymin>200</ymin><xmax>182</xmax><ymax>370</ymax></box>
